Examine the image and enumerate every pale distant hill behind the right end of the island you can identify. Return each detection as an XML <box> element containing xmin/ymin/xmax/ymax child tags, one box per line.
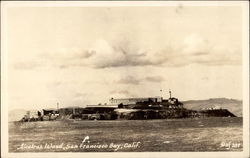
<box><xmin>182</xmin><ymin>98</ymin><xmax>243</xmax><ymax>117</ymax></box>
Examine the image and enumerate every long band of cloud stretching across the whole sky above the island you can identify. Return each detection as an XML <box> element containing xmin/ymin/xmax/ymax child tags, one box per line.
<box><xmin>15</xmin><ymin>33</ymin><xmax>241</xmax><ymax>69</ymax></box>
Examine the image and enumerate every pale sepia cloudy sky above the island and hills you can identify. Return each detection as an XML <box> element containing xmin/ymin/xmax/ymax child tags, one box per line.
<box><xmin>6</xmin><ymin>5</ymin><xmax>242</xmax><ymax>109</ymax></box>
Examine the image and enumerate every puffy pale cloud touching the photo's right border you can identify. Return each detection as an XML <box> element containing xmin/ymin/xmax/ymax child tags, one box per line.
<box><xmin>183</xmin><ymin>34</ymin><xmax>241</xmax><ymax>66</ymax></box>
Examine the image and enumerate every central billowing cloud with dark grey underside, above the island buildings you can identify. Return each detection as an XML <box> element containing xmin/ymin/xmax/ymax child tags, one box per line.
<box><xmin>87</xmin><ymin>39</ymin><xmax>169</xmax><ymax>68</ymax></box>
